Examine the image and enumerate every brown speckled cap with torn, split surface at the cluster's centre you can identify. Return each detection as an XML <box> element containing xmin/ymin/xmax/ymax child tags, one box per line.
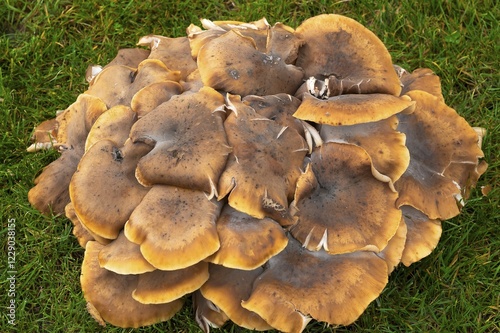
<box><xmin>218</xmin><ymin>96</ymin><xmax>308</xmax><ymax>225</ymax></box>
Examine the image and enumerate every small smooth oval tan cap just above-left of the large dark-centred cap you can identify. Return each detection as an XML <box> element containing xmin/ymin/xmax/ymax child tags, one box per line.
<box><xmin>130</xmin><ymin>81</ymin><xmax>183</xmax><ymax>118</ymax></box>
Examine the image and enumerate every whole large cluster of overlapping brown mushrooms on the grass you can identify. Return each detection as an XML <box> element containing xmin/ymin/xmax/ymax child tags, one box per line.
<box><xmin>29</xmin><ymin>14</ymin><xmax>487</xmax><ymax>332</ymax></box>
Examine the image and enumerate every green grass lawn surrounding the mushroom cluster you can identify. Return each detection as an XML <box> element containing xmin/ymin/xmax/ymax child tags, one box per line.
<box><xmin>0</xmin><ymin>0</ymin><xmax>500</xmax><ymax>333</ymax></box>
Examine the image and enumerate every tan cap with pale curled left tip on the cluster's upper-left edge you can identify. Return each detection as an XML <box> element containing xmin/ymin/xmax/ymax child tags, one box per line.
<box><xmin>137</xmin><ymin>35</ymin><xmax>196</xmax><ymax>80</ymax></box>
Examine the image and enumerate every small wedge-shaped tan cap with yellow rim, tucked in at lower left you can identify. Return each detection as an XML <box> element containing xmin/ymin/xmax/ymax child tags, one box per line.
<box><xmin>99</xmin><ymin>230</ymin><xmax>153</xmax><ymax>274</ymax></box>
